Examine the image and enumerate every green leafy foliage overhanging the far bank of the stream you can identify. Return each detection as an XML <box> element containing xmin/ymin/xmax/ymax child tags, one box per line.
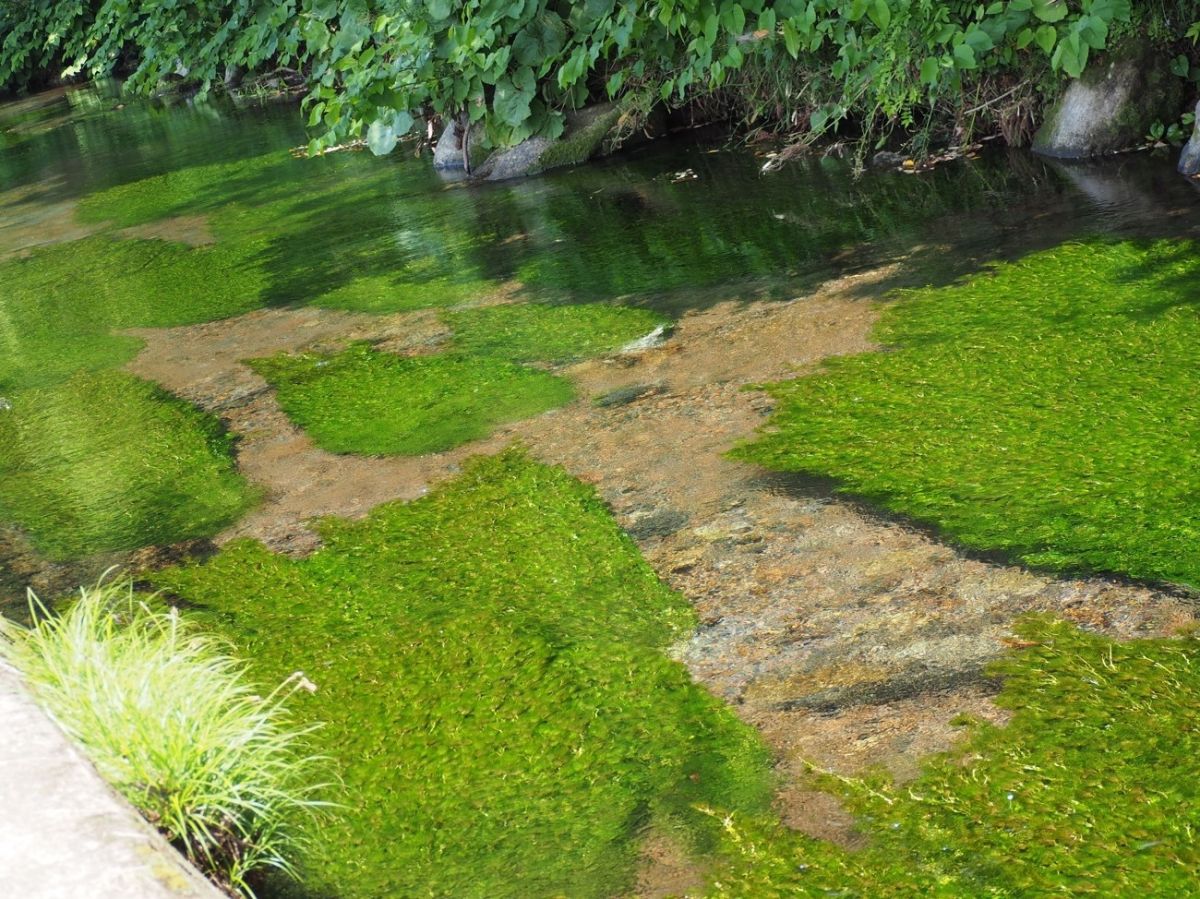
<box><xmin>0</xmin><ymin>0</ymin><xmax>1152</xmax><ymax>152</ymax></box>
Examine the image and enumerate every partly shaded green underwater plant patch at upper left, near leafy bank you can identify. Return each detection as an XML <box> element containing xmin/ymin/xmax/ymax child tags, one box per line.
<box><xmin>78</xmin><ymin>152</ymin><xmax>506</xmax><ymax>313</ymax></box>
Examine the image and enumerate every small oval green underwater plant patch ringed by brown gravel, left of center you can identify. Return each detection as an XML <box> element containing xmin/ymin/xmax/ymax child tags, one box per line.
<box><xmin>252</xmin><ymin>344</ymin><xmax>575</xmax><ymax>455</ymax></box>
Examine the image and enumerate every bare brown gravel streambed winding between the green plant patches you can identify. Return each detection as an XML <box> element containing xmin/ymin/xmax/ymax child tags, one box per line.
<box><xmin>110</xmin><ymin>270</ymin><xmax>1193</xmax><ymax>854</ymax></box>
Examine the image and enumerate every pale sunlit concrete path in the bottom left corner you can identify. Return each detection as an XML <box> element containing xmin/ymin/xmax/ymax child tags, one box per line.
<box><xmin>0</xmin><ymin>664</ymin><xmax>222</xmax><ymax>899</ymax></box>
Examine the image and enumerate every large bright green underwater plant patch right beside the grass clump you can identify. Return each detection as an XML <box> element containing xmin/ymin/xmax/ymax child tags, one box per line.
<box><xmin>160</xmin><ymin>453</ymin><xmax>769</xmax><ymax>899</ymax></box>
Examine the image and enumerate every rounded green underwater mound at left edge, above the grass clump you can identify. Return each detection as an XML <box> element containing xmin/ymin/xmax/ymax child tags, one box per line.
<box><xmin>0</xmin><ymin>372</ymin><xmax>253</xmax><ymax>559</ymax></box>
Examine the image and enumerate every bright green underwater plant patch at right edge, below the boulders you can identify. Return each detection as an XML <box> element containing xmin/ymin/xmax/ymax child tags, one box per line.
<box><xmin>737</xmin><ymin>242</ymin><xmax>1200</xmax><ymax>586</ymax></box>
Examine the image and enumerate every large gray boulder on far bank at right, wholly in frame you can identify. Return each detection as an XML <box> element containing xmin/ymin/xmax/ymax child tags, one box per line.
<box><xmin>1033</xmin><ymin>44</ymin><xmax>1183</xmax><ymax>160</ymax></box>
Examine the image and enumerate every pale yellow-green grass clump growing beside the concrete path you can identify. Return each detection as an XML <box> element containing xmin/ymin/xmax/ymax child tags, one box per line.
<box><xmin>0</xmin><ymin>582</ymin><xmax>322</xmax><ymax>895</ymax></box>
